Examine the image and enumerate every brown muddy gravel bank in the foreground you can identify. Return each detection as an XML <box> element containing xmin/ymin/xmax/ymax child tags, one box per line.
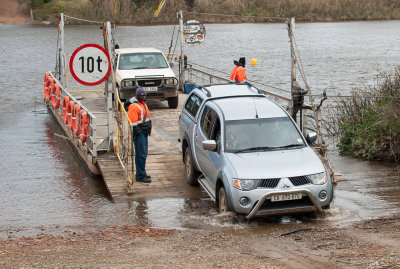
<box><xmin>0</xmin><ymin>215</ymin><xmax>400</xmax><ymax>268</ymax></box>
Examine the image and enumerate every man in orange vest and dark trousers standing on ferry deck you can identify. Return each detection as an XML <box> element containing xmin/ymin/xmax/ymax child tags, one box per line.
<box><xmin>127</xmin><ymin>87</ymin><xmax>151</xmax><ymax>183</ymax></box>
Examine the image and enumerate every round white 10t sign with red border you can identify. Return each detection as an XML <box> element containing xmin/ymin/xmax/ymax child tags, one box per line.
<box><xmin>69</xmin><ymin>44</ymin><xmax>111</xmax><ymax>86</ymax></box>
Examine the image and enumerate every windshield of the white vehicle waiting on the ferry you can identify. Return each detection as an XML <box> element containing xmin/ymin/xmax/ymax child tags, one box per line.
<box><xmin>118</xmin><ymin>52</ymin><xmax>169</xmax><ymax>70</ymax></box>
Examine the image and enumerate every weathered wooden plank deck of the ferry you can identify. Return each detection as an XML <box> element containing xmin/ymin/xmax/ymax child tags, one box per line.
<box><xmin>49</xmin><ymin>87</ymin><xmax>205</xmax><ymax>201</ymax></box>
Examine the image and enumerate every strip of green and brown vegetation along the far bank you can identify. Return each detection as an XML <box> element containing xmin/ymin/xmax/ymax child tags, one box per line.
<box><xmin>30</xmin><ymin>0</ymin><xmax>400</xmax><ymax>24</ymax></box>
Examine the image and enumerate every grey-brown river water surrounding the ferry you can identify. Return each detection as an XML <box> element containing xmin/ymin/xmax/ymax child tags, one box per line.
<box><xmin>0</xmin><ymin>21</ymin><xmax>400</xmax><ymax>231</ymax></box>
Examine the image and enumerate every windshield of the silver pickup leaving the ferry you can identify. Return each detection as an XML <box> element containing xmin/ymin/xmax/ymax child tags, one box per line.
<box><xmin>225</xmin><ymin>117</ymin><xmax>305</xmax><ymax>153</ymax></box>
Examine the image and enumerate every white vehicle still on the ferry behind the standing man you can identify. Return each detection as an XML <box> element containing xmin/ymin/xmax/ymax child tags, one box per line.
<box><xmin>115</xmin><ymin>48</ymin><xmax>178</xmax><ymax>108</ymax></box>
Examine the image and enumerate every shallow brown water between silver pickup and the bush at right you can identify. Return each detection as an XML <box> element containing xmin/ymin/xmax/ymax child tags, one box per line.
<box><xmin>328</xmin><ymin>151</ymin><xmax>400</xmax><ymax>220</ymax></box>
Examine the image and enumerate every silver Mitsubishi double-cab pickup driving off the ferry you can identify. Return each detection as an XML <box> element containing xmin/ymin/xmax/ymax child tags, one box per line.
<box><xmin>179</xmin><ymin>83</ymin><xmax>333</xmax><ymax>218</ymax></box>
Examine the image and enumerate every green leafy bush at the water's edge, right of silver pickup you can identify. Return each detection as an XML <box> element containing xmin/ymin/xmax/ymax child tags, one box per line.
<box><xmin>336</xmin><ymin>67</ymin><xmax>400</xmax><ymax>164</ymax></box>
